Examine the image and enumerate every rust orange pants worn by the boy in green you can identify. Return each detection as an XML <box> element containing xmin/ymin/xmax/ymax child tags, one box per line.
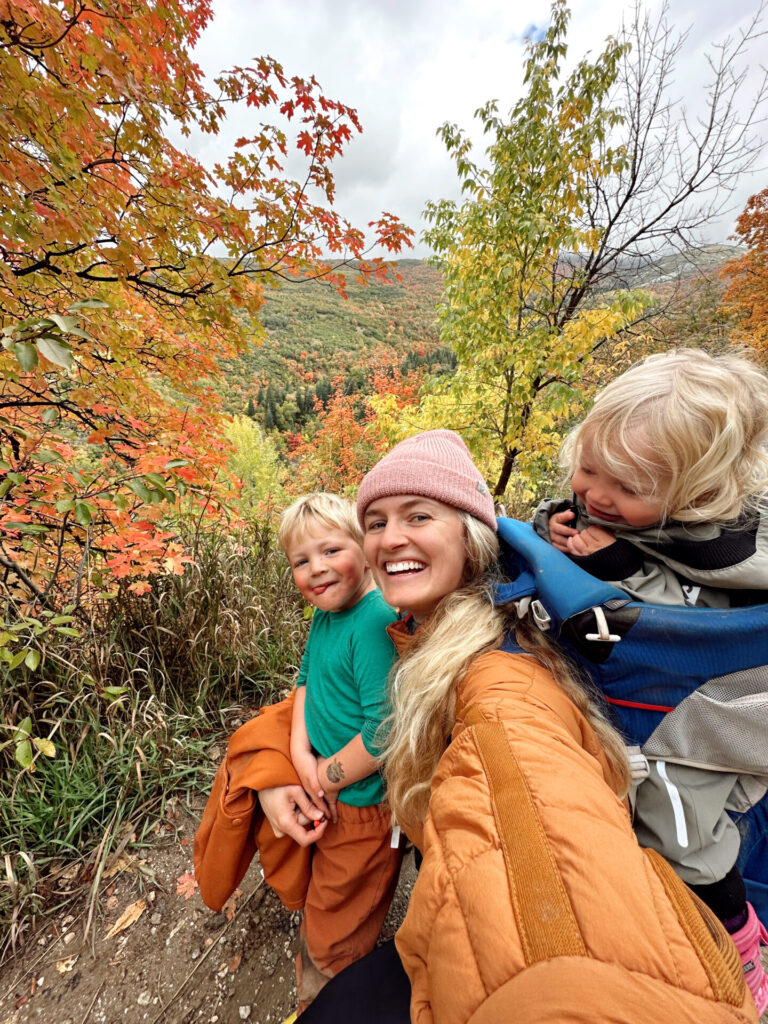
<box><xmin>301</xmin><ymin>803</ymin><xmax>402</xmax><ymax>974</ymax></box>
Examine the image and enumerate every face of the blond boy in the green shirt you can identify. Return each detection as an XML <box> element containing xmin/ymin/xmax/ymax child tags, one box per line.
<box><xmin>286</xmin><ymin>522</ymin><xmax>373</xmax><ymax>611</ymax></box>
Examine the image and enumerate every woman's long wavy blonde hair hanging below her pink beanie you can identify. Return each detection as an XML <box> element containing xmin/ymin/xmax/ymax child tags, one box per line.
<box><xmin>381</xmin><ymin>510</ymin><xmax>629</xmax><ymax>827</ymax></box>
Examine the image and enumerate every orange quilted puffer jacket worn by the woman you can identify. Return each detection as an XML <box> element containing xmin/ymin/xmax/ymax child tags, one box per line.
<box><xmin>390</xmin><ymin>647</ymin><xmax>757</xmax><ymax>1024</ymax></box>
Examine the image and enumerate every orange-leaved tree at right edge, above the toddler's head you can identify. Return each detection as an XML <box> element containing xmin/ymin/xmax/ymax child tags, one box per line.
<box><xmin>723</xmin><ymin>188</ymin><xmax>768</xmax><ymax>360</ymax></box>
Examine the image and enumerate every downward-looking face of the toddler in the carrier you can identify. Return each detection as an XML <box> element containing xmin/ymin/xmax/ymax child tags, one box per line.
<box><xmin>570</xmin><ymin>444</ymin><xmax>665</xmax><ymax>529</ymax></box>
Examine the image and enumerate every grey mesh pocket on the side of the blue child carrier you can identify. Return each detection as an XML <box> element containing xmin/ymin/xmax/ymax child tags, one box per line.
<box><xmin>643</xmin><ymin>666</ymin><xmax>768</xmax><ymax>781</ymax></box>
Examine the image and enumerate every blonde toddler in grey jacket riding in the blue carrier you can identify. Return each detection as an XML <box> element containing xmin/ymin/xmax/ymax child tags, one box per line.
<box><xmin>534</xmin><ymin>349</ymin><xmax>768</xmax><ymax>1013</ymax></box>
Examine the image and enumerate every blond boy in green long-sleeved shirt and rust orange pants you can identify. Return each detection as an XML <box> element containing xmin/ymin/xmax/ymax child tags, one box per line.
<box><xmin>279</xmin><ymin>494</ymin><xmax>400</xmax><ymax>1011</ymax></box>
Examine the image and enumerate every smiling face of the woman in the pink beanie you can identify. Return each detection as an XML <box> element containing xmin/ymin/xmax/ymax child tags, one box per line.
<box><xmin>364</xmin><ymin>495</ymin><xmax>467</xmax><ymax>623</ymax></box>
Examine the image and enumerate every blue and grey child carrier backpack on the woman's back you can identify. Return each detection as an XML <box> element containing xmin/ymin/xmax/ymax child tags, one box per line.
<box><xmin>496</xmin><ymin>518</ymin><xmax>768</xmax><ymax>926</ymax></box>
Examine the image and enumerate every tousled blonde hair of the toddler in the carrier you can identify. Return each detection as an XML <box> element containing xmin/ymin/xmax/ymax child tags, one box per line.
<box><xmin>561</xmin><ymin>348</ymin><xmax>768</xmax><ymax>522</ymax></box>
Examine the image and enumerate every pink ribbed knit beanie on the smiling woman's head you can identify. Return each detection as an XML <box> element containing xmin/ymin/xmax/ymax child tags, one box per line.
<box><xmin>357</xmin><ymin>430</ymin><xmax>497</xmax><ymax>530</ymax></box>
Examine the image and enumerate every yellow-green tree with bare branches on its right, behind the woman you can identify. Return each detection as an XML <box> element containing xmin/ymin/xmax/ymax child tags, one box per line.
<box><xmin>420</xmin><ymin>0</ymin><xmax>766</xmax><ymax>497</ymax></box>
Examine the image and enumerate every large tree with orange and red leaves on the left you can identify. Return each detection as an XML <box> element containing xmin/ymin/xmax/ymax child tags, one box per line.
<box><xmin>0</xmin><ymin>0</ymin><xmax>409</xmax><ymax>607</ymax></box>
